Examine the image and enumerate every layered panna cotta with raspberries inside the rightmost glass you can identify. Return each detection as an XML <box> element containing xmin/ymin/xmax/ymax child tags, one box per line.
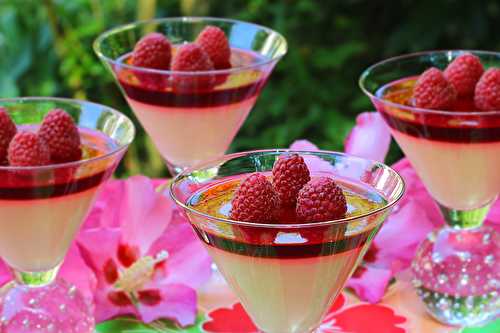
<box><xmin>374</xmin><ymin>53</ymin><xmax>500</xmax><ymax>210</ymax></box>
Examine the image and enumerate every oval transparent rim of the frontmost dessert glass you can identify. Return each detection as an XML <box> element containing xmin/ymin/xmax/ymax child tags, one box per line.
<box><xmin>169</xmin><ymin>149</ymin><xmax>406</xmax><ymax>229</ymax></box>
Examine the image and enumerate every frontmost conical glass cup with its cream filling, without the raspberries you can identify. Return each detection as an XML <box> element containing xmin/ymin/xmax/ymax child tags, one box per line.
<box><xmin>170</xmin><ymin>150</ymin><xmax>404</xmax><ymax>333</ymax></box>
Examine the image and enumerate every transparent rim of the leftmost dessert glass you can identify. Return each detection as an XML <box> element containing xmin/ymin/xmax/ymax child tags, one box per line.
<box><xmin>0</xmin><ymin>97</ymin><xmax>136</xmax><ymax>171</ymax></box>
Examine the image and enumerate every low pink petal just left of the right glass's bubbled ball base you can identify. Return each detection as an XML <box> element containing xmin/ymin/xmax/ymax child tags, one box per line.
<box><xmin>346</xmin><ymin>265</ymin><xmax>393</xmax><ymax>303</ymax></box>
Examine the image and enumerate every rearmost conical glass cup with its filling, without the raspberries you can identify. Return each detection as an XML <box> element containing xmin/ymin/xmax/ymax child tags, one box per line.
<box><xmin>94</xmin><ymin>17</ymin><xmax>287</xmax><ymax>175</ymax></box>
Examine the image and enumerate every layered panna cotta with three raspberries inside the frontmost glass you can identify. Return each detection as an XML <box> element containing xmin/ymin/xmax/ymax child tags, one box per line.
<box><xmin>187</xmin><ymin>154</ymin><xmax>387</xmax><ymax>333</ymax></box>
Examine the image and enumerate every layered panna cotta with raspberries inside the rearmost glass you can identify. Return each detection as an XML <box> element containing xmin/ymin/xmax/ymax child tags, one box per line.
<box><xmin>114</xmin><ymin>26</ymin><xmax>269</xmax><ymax>168</ymax></box>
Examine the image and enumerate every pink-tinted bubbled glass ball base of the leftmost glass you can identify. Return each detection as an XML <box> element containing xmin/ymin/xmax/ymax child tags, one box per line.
<box><xmin>0</xmin><ymin>280</ymin><xmax>95</xmax><ymax>333</ymax></box>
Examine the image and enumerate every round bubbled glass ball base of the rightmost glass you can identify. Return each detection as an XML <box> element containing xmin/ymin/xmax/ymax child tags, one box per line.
<box><xmin>412</xmin><ymin>226</ymin><xmax>500</xmax><ymax>326</ymax></box>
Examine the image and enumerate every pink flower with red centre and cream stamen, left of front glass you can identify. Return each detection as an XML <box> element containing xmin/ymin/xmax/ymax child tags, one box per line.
<box><xmin>77</xmin><ymin>177</ymin><xmax>211</xmax><ymax>326</ymax></box>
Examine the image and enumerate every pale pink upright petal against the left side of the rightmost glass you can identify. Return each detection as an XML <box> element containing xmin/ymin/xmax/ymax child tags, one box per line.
<box><xmin>344</xmin><ymin>112</ymin><xmax>391</xmax><ymax>162</ymax></box>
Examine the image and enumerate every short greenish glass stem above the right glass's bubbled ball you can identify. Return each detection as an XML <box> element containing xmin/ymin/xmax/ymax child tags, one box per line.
<box><xmin>439</xmin><ymin>200</ymin><xmax>494</xmax><ymax>229</ymax></box>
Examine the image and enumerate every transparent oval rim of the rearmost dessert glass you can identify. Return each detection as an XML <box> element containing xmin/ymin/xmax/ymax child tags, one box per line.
<box><xmin>93</xmin><ymin>16</ymin><xmax>288</xmax><ymax>76</ymax></box>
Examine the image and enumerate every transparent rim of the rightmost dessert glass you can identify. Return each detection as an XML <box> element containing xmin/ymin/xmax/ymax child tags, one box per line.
<box><xmin>358</xmin><ymin>49</ymin><xmax>500</xmax><ymax>117</ymax></box>
